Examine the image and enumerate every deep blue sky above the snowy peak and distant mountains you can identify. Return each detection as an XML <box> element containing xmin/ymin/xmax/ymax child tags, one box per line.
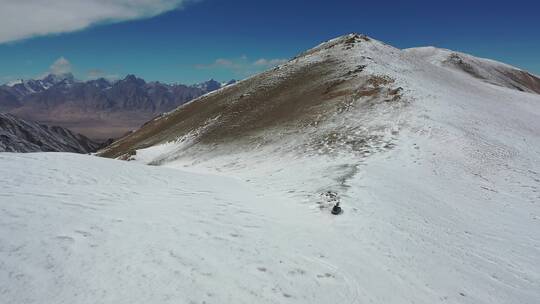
<box><xmin>0</xmin><ymin>0</ymin><xmax>540</xmax><ymax>83</ymax></box>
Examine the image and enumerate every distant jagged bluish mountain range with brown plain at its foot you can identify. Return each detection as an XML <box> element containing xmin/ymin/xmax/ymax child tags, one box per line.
<box><xmin>0</xmin><ymin>74</ymin><xmax>235</xmax><ymax>140</ymax></box>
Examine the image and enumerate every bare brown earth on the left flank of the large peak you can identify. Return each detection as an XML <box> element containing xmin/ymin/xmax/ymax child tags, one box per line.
<box><xmin>101</xmin><ymin>36</ymin><xmax>401</xmax><ymax>158</ymax></box>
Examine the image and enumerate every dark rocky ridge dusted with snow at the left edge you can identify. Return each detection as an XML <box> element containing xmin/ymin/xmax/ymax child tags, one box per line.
<box><xmin>0</xmin><ymin>113</ymin><xmax>102</xmax><ymax>153</ymax></box>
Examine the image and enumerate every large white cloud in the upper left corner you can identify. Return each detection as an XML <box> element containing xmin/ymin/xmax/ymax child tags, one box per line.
<box><xmin>0</xmin><ymin>0</ymin><xmax>193</xmax><ymax>43</ymax></box>
